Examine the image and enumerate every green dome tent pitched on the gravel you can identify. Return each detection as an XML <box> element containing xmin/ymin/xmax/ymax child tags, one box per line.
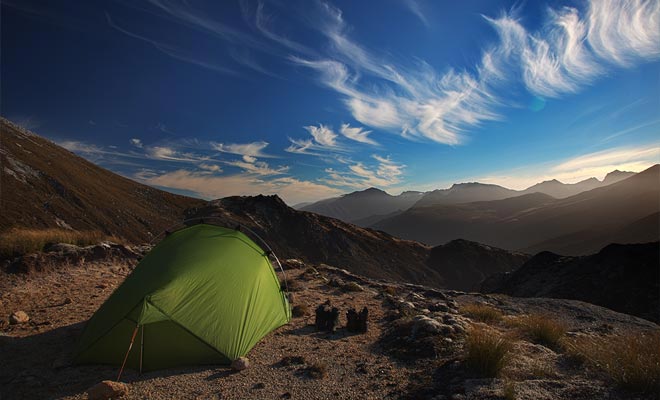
<box><xmin>74</xmin><ymin>224</ymin><xmax>291</xmax><ymax>371</ymax></box>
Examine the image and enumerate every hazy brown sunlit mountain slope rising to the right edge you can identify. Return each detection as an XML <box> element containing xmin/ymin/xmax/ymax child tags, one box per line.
<box><xmin>374</xmin><ymin>165</ymin><xmax>660</xmax><ymax>255</ymax></box>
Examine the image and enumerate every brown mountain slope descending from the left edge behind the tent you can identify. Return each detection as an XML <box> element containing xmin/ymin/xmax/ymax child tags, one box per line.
<box><xmin>0</xmin><ymin>118</ymin><xmax>205</xmax><ymax>242</ymax></box>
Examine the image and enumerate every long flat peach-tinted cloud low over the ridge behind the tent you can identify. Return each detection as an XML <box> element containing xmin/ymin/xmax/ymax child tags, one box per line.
<box><xmin>142</xmin><ymin>169</ymin><xmax>343</xmax><ymax>205</ymax></box>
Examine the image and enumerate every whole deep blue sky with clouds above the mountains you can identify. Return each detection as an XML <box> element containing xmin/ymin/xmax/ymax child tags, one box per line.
<box><xmin>1</xmin><ymin>0</ymin><xmax>660</xmax><ymax>204</ymax></box>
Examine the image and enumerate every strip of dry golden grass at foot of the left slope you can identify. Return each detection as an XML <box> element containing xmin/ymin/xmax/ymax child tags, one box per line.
<box><xmin>0</xmin><ymin>228</ymin><xmax>124</xmax><ymax>257</ymax></box>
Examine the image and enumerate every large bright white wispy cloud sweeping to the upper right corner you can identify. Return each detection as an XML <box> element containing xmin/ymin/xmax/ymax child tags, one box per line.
<box><xmin>290</xmin><ymin>0</ymin><xmax>660</xmax><ymax>144</ymax></box>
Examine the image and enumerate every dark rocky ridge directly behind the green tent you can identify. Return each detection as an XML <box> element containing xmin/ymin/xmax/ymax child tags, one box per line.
<box><xmin>188</xmin><ymin>196</ymin><xmax>529</xmax><ymax>289</ymax></box>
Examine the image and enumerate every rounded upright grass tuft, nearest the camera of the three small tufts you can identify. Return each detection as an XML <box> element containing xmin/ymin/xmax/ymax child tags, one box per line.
<box><xmin>465</xmin><ymin>327</ymin><xmax>512</xmax><ymax>378</ymax></box>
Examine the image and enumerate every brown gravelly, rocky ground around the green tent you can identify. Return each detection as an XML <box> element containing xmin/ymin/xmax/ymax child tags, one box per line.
<box><xmin>0</xmin><ymin>261</ymin><xmax>658</xmax><ymax>400</ymax></box>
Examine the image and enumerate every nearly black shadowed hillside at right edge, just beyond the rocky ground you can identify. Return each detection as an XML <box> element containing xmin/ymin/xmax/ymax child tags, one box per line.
<box><xmin>481</xmin><ymin>242</ymin><xmax>660</xmax><ymax>322</ymax></box>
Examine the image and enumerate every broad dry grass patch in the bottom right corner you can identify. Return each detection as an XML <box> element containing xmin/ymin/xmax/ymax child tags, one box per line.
<box><xmin>565</xmin><ymin>331</ymin><xmax>660</xmax><ymax>393</ymax></box>
